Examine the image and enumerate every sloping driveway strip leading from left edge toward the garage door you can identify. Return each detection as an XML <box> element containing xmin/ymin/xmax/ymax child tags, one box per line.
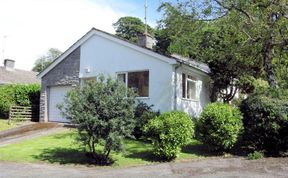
<box><xmin>0</xmin><ymin>124</ymin><xmax>67</xmax><ymax>147</ymax></box>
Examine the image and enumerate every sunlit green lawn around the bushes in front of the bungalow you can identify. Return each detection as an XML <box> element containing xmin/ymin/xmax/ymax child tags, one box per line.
<box><xmin>0</xmin><ymin>131</ymin><xmax>212</xmax><ymax>167</ymax></box>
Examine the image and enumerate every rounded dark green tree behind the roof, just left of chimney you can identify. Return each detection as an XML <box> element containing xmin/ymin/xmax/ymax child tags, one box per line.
<box><xmin>113</xmin><ymin>16</ymin><xmax>154</xmax><ymax>43</ymax></box>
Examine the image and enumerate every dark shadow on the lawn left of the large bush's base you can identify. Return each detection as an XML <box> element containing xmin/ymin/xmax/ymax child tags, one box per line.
<box><xmin>33</xmin><ymin>147</ymin><xmax>95</xmax><ymax>165</ymax></box>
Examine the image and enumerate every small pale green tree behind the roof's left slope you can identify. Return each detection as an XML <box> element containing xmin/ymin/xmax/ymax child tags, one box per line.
<box><xmin>32</xmin><ymin>48</ymin><xmax>62</xmax><ymax>72</ymax></box>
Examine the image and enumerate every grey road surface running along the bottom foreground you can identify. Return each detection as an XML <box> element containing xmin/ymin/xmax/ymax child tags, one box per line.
<box><xmin>0</xmin><ymin>158</ymin><xmax>288</xmax><ymax>178</ymax></box>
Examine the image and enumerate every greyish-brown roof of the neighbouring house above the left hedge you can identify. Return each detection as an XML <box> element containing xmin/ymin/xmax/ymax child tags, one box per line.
<box><xmin>0</xmin><ymin>66</ymin><xmax>40</xmax><ymax>85</ymax></box>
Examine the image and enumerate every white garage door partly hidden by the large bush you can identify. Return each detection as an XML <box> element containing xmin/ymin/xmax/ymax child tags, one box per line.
<box><xmin>48</xmin><ymin>86</ymin><xmax>72</xmax><ymax>122</ymax></box>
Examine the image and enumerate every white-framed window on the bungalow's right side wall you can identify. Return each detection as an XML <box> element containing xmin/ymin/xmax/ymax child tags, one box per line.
<box><xmin>182</xmin><ymin>74</ymin><xmax>197</xmax><ymax>99</ymax></box>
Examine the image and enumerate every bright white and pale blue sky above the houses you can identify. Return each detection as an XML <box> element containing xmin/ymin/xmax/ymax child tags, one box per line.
<box><xmin>0</xmin><ymin>0</ymin><xmax>176</xmax><ymax>70</ymax></box>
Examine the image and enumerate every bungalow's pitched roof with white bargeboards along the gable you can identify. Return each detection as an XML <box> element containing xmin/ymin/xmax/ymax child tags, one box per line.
<box><xmin>38</xmin><ymin>28</ymin><xmax>210</xmax><ymax>78</ymax></box>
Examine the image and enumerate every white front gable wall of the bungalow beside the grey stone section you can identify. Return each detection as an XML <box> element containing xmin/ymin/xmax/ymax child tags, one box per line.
<box><xmin>79</xmin><ymin>35</ymin><xmax>174</xmax><ymax>112</ymax></box>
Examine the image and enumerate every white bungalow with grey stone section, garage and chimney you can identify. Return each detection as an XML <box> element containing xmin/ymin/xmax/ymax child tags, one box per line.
<box><xmin>38</xmin><ymin>28</ymin><xmax>210</xmax><ymax>122</ymax></box>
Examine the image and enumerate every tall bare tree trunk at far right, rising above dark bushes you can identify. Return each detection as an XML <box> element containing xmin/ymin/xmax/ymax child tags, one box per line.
<box><xmin>263</xmin><ymin>32</ymin><xmax>277</xmax><ymax>88</ymax></box>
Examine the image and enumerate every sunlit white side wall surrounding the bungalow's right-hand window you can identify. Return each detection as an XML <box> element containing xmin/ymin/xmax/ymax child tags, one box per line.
<box><xmin>176</xmin><ymin>65</ymin><xmax>210</xmax><ymax>117</ymax></box>
